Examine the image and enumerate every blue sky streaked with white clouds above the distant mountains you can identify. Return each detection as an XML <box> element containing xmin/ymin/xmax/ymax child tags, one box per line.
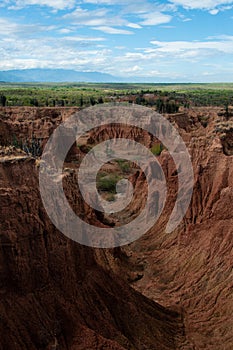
<box><xmin>0</xmin><ymin>0</ymin><xmax>233</xmax><ymax>82</ymax></box>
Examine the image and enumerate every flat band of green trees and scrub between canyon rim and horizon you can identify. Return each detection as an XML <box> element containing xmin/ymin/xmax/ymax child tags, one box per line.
<box><xmin>0</xmin><ymin>83</ymin><xmax>233</xmax><ymax>108</ymax></box>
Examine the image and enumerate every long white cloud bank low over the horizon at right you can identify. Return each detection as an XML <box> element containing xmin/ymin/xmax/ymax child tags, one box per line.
<box><xmin>108</xmin><ymin>36</ymin><xmax>233</xmax><ymax>77</ymax></box>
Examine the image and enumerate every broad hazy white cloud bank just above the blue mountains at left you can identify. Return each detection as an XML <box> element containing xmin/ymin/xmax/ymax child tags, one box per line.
<box><xmin>0</xmin><ymin>33</ymin><xmax>112</xmax><ymax>71</ymax></box>
